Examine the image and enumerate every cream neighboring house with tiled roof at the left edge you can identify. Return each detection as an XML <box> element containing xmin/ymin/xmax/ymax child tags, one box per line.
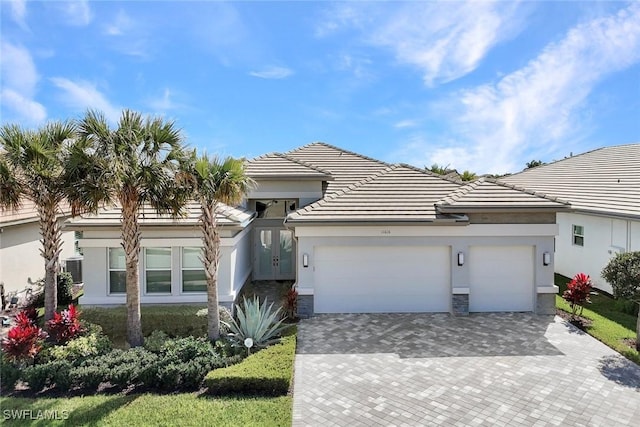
<box><xmin>0</xmin><ymin>201</ymin><xmax>78</xmax><ymax>293</ymax></box>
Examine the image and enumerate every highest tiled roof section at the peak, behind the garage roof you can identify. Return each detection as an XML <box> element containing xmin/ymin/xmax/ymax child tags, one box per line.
<box><xmin>285</xmin><ymin>142</ymin><xmax>389</xmax><ymax>194</ymax></box>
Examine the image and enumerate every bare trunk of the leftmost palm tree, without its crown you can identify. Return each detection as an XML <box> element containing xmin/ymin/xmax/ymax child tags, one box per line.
<box><xmin>38</xmin><ymin>200</ymin><xmax>62</xmax><ymax>321</ymax></box>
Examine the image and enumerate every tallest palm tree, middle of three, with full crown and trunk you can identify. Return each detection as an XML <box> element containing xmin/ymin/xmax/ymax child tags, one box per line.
<box><xmin>66</xmin><ymin>110</ymin><xmax>190</xmax><ymax>347</ymax></box>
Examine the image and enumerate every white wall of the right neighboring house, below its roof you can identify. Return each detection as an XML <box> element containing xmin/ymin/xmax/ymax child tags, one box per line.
<box><xmin>556</xmin><ymin>213</ymin><xmax>640</xmax><ymax>292</ymax></box>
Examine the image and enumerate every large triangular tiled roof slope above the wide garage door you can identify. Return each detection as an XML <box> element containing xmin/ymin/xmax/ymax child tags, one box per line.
<box><xmin>286</xmin><ymin>165</ymin><xmax>466</xmax><ymax>223</ymax></box>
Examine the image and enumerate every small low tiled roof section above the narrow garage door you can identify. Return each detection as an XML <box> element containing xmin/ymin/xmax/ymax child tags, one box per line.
<box><xmin>436</xmin><ymin>178</ymin><xmax>569</xmax><ymax>213</ymax></box>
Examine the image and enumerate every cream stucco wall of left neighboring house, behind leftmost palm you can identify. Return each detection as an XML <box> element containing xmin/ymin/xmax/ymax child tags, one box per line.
<box><xmin>0</xmin><ymin>222</ymin><xmax>75</xmax><ymax>293</ymax></box>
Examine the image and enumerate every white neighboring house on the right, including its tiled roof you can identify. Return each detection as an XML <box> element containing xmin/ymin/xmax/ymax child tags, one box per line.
<box><xmin>502</xmin><ymin>144</ymin><xmax>640</xmax><ymax>292</ymax></box>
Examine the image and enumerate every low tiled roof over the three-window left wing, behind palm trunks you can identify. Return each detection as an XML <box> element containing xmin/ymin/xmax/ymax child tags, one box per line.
<box><xmin>67</xmin><ymin>202</ymin><xmax>254</xmax><ymax>229</ymax></box>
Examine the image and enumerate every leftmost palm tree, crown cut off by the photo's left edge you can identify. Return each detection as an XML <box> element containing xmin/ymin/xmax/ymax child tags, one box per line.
<box><xmin>0</xmin><ymin>122</ymin><xmax>76</xmax><ymax>320</ymax></box>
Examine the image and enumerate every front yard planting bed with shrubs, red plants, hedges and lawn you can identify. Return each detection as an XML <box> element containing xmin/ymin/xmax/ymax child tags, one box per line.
<box><xmin>0</xmin><ymin>306</ymin><xmax>296</xmax><ymax>426</ymax></box>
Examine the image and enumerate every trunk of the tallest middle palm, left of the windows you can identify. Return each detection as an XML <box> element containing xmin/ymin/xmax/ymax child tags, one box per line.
<box><xmin>120</xmin><ymin>196</ymin><xmax>144</xmax><ymax>347</ymax></box>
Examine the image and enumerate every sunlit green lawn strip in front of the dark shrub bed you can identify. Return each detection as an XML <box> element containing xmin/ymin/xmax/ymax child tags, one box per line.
<box><xmin>0</xmin><ymin>393</ymin><xmax>292</xmax><ymax>426</ymax></box>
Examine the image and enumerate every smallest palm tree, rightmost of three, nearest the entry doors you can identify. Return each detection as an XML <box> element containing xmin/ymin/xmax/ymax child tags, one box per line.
<box><xmin>193</xmin><ymin>154</ymin><xmax>253</xmax><ymax>341</ymax></box>
